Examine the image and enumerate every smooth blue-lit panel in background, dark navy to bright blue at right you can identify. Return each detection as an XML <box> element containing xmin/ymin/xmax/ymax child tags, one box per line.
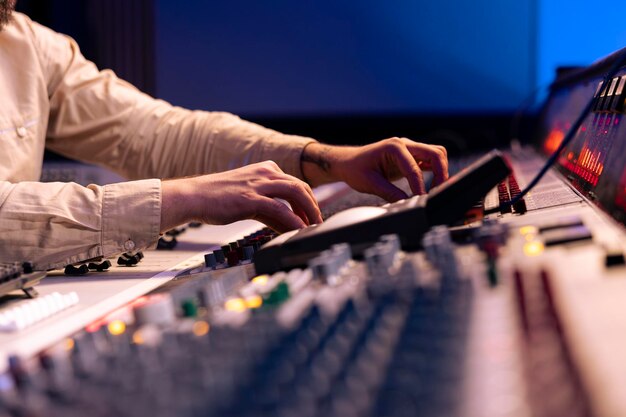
<box><xmin>156</xmin><ymin>0</ymin><xmax>626</xmax><ymax>116</ymax></box>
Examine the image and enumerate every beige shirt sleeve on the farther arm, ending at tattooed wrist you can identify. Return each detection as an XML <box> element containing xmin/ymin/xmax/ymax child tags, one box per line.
<box><xmin>31</xmin><ymin>18</ymin><xmax>314</xmax><ymax>179</ymax></box>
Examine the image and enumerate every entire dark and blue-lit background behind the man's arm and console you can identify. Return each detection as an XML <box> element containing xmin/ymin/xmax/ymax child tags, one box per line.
<box><xmin>17</xmin><ymin>0</ymin><xmax>626</xmax><ymax>154</ymax></box>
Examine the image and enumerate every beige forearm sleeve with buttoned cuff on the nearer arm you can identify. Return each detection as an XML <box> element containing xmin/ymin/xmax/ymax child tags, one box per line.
<box><xmin>0</xmin><ymin>179</ymin><xmax>161</xmax><ymax>270</ymax></box>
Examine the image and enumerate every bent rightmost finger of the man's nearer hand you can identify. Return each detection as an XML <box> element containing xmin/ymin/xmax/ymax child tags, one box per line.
<box><xmin>257</xmin><ymin>180</ymin><xmax>322</xmax><ymax>224</ymax></box>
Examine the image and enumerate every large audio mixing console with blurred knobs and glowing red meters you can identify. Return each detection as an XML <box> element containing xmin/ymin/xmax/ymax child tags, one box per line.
<box><xmin>0</xmin><ymin>51</ymin><xmax>626</xmax><ymax>417</ymax></box>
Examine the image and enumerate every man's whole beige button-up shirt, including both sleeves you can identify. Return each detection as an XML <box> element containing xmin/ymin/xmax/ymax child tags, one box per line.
<box><xmin>0</xmin><ymin>13</ymin><xmax>313</xmax><ymax>269</ymax></box>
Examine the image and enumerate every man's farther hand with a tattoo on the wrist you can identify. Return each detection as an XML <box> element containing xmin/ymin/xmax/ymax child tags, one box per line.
<box><xmin>302</xmin><ymin>138</ymin><xmax>448</xmax><ymax>202</ymax></box>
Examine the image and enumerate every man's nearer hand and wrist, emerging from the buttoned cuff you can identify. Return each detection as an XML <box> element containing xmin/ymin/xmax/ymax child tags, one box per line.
<box><xmin>161</xmin><ymin>161</ymin><xmax>322</xmax><ymax>232</ymax></box>
